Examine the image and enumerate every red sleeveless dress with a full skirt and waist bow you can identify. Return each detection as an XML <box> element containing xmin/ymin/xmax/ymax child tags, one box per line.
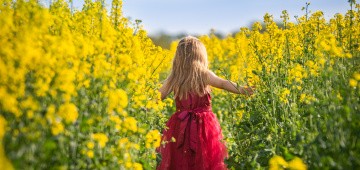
<box><xmin>156</xmin><ymin>93</ymin><xmax>228</xmax><ymax>170</ymax></box>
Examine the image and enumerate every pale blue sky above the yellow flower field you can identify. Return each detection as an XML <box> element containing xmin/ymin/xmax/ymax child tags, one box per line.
<box><xmin>69</xmin><ymin>0</ymin><xmax>350</xmax><ymax>35</ymax></box>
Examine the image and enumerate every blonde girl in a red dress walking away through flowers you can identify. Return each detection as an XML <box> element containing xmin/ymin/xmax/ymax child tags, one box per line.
<box><xmin>157</xmin><ymin>36</ymin><xmax>253</xmax><ymax>170</ymax></box>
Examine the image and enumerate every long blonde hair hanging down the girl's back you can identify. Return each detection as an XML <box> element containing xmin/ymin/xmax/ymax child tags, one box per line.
<box><xmin>165</xmin><ymin>36</ymin><xmax>210</xmax><ymax>99</ymax></box>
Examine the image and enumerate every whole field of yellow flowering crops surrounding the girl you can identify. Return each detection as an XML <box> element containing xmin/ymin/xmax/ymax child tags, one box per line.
<box><xmin>0</xmin><ymin>0</ymin><xmax>360</xmax><ymax>170</ymax></box>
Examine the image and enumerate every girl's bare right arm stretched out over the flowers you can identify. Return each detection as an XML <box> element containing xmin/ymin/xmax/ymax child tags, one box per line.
<box><xmin>208</xmin><ymin>70</ymin><xmax>254</xmax><ymax>96</ymax></box>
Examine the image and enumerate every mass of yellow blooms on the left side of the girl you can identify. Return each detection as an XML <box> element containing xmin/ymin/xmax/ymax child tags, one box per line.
<box><xmin>0</xmin><ymin>0</ymin><xmax>172</xmax><ymax>169</ymax></box>
